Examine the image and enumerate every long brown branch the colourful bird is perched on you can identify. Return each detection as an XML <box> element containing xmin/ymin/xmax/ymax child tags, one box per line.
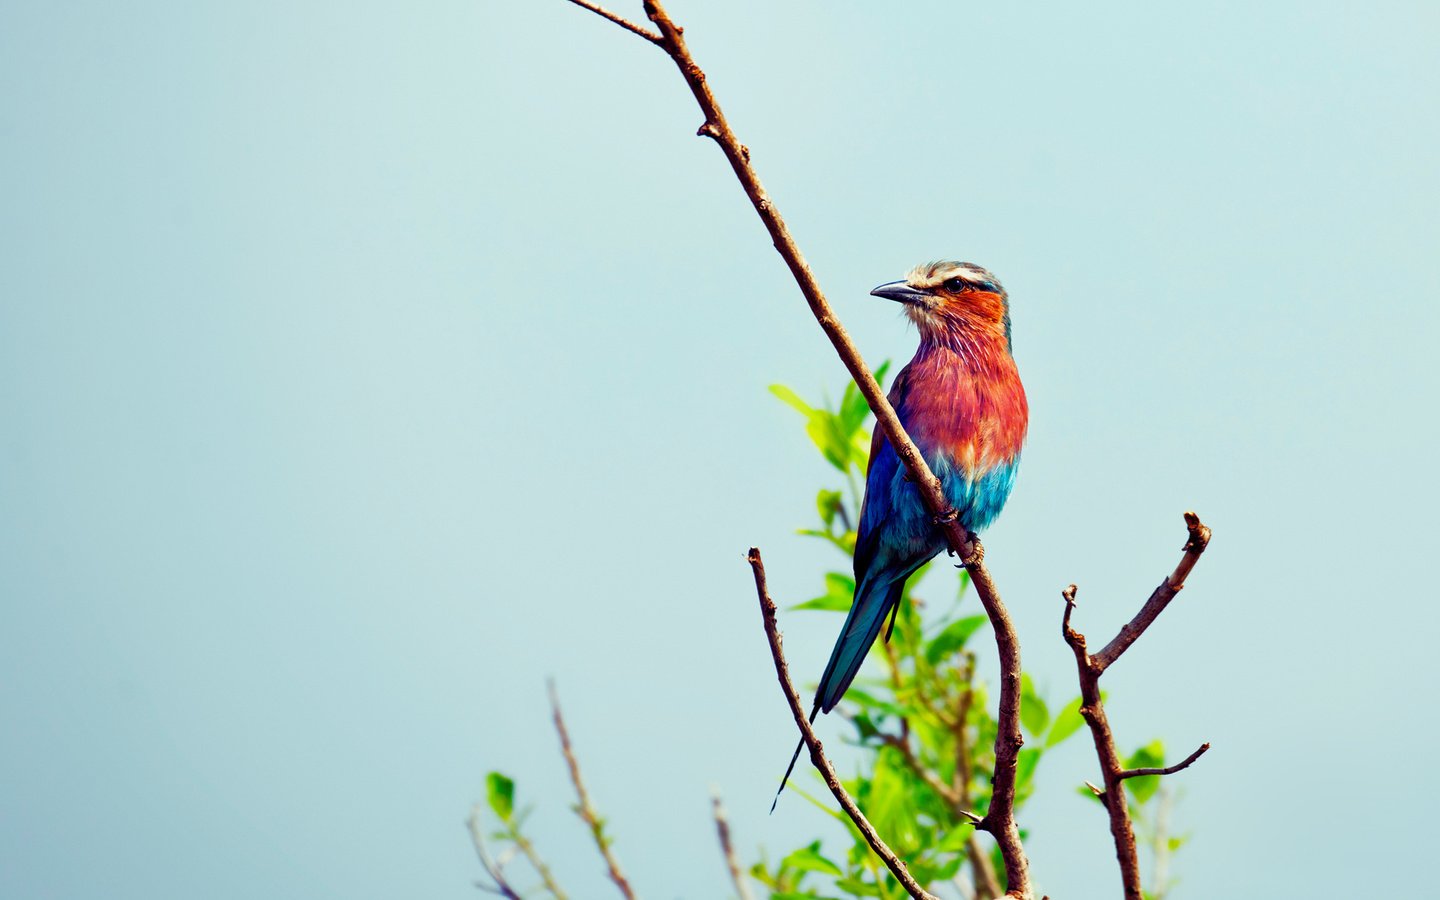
<box><xmin>572</xmin><ymin>0</ymin><xmax>1032</xmax><ymax>900</ymax></box>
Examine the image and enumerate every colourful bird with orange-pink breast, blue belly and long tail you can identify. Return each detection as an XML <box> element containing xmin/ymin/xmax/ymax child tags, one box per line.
<box><xmin>770</xmin><ymin>261</ymin><xmax>1030</xmax><ymax>811</ymax></box>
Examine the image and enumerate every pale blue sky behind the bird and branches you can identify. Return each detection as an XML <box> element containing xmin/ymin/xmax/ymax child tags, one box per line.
<box><xmin>0</xmin><ymin>0</ymin><xmax>1440</xmax><ymax>900</ymax></box>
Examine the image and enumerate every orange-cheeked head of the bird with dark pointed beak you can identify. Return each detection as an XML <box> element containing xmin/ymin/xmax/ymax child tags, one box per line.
<box><xmin>871</xmin><ymin>261</ymin><xmax>1009</xmax><ymax>348</ymax></box>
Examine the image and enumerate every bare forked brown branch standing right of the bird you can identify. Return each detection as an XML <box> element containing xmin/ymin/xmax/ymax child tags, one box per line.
<box><xmin>1060</xmin><ymin>513</ymin><xmax>1210</xmax><ymax>900</ymax></box>
